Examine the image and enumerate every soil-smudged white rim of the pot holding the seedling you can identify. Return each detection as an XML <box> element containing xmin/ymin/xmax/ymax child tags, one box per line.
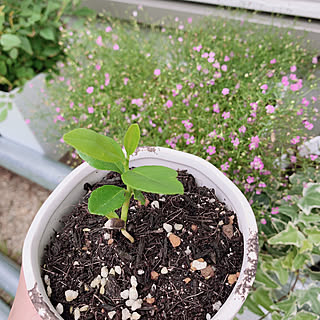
<box><xmin>22</xmin><ymin>147</ymin><xmax>259</xmax><ymax>320</ymax></box>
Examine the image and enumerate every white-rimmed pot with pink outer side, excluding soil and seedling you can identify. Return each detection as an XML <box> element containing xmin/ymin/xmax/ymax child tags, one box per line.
<box><xmin>9</xmin><ymin>147</ymin><xmax>258</xmax><ymax>320</ymax></box>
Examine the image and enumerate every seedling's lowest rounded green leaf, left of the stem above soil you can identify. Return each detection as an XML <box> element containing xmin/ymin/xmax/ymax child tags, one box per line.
<box><xmin>88</xmin><ymin>185</ymin><xmax>126</xmax><ymax>218</ymax></box>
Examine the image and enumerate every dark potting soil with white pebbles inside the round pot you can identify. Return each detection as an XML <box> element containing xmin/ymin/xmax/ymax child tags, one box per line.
<box><xmin>42</xmin><ymin>171</ymin><xmax>243</xmax><ymax>320</ymax></box>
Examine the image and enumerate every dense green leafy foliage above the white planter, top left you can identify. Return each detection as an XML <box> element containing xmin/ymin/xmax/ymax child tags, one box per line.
<box><xmin>0</xmin><ymin>0</ymin><xmax>92</xmax><ymax>91</ymax></box>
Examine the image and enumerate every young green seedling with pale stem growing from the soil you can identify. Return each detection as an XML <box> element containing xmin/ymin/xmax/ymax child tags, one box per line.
<box><xmin>63</xmin><ymin>124</ymin><xmax>183</xmax><ymax>242</ymax></box>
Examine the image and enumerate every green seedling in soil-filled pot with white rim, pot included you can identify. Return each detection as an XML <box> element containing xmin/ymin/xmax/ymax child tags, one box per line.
<box><xmin>9</xmin><ymin>124</ymin><xmax>258</xmax><ymax>320</ymax></box>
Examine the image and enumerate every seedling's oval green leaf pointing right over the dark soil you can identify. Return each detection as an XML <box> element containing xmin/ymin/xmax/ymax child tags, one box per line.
<box><xmin>121</xmin><ymin>166</ymin><xmax>183</xmax><ymax>194</ymax></box>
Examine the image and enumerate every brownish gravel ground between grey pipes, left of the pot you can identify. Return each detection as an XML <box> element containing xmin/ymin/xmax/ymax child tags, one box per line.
<box><xmin>0</xmin><ymin>167</ymin><xmax>50</xmax><ymax>263</ymax></box>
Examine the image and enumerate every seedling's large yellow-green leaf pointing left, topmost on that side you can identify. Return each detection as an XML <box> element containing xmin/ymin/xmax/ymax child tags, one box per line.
<box><xmin>63</xmin><ymin>129</ymin><xmax>125</xmax><ymax>163</ymax></box>
